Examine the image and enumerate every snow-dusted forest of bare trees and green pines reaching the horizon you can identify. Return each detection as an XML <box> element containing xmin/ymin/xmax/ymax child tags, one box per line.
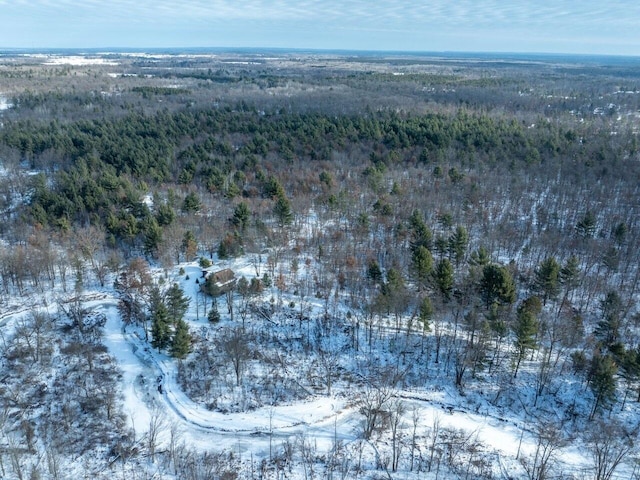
<box><xmin>0</xmin><ymin>54</ymin><xmax>640</xmax><ymax>480</ymax></box>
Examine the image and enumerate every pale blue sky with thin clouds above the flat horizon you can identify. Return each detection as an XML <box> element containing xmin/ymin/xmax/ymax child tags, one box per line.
<box><xmin>0</xmin><ymin>0</ymin><xmax>640</xmax><ymax>55</ymax></box>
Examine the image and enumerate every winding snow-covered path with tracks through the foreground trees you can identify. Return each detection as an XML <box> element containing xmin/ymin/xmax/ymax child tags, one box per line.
<box><xmin>94</xmin><ymin>299</ymin><xmax>540</xmax><ymax>464</ymax></box>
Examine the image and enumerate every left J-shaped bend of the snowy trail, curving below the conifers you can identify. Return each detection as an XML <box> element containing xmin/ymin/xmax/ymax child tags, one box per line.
<box><xmin>93</xmin><ymin>298</ymin><xmax>355</xmax><ymax>448</ymax></box>
